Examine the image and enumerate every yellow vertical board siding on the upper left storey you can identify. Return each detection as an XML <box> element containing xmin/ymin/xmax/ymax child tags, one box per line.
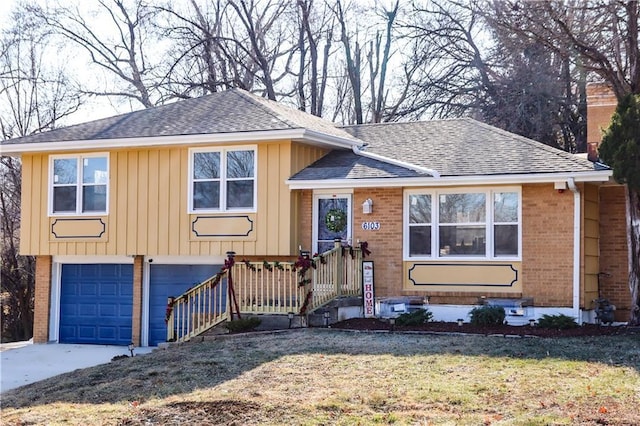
<box><xmin>21</xmin><ymin>141</ymin><xmax>326</xmax><ymax>256</ymax></box>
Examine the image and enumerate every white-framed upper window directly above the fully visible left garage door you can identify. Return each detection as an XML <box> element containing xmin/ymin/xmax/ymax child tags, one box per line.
<box><xmin>50</xmin><ymin>154</ymin><xmax>109</xmax><ymax>215</ymax></box>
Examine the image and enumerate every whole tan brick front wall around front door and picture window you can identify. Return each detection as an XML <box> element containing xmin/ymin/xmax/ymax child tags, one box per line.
<box><xmin>301</xmin><ymin>184</ymin><xmax>584</xmax><ymax>307</ymax></box>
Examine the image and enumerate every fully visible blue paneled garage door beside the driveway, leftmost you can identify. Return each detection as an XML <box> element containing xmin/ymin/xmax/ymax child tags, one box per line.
<box><xmin>60</xmin><ymin>264</ymin><xmax>133</xmax><ymax>345</ymax></box>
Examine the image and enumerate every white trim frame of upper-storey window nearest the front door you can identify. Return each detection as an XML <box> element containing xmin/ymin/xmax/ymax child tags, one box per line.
<box><xmin>187</xmin><ymin>145</ymin><xmax>258</xmax><ymax>214</ymax></box>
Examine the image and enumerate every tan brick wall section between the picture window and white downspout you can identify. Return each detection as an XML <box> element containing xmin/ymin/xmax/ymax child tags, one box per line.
<box><xmin>522</xmin><ymin>184</ymin><xmax>573</xmax><ymax>306</ymax></box>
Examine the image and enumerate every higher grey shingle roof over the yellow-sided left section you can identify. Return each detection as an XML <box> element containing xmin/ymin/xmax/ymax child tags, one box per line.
<box><xmin>3</xmin><ymin>89</ymin><xmax>354</xmax><ymax>145</ymax></box>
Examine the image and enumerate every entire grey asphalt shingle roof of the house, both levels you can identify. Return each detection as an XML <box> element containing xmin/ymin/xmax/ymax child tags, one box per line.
<box><xmin>2</xmin><ymin>89</ymin><xmax>595</xmax><ymax>181</ymax></box>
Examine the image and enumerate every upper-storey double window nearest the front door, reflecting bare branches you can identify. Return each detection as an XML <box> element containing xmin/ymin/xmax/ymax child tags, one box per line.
<box><xmin>190</xmin><ymin>148</ymin><xmax>256</xmax><ymax>212</ymax></box>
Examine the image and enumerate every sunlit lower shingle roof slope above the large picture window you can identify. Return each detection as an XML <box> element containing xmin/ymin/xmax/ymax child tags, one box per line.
<box><xmin>336</xmin><ymin>118</ymin><xmax>594</xmax><ymax>178</ymax></box>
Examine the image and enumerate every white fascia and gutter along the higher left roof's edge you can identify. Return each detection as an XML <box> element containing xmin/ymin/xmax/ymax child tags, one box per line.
<box><xmin>0</xmin><ymin>128</ymin><xmax>358</xmax><ymax>156</ymax></box>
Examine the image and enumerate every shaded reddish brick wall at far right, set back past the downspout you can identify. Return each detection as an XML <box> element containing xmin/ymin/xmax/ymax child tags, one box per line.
<box><xmin>600</xmin><ymin>185</ymin><xmax>631</xmax><ymax>321</ymax></box>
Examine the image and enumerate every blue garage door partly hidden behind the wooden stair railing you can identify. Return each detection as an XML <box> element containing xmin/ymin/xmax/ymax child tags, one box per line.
<box><xmin>149</xmin><ymin>264</ymin><xmax>222</xmax><ymax>346</ymax></box>
